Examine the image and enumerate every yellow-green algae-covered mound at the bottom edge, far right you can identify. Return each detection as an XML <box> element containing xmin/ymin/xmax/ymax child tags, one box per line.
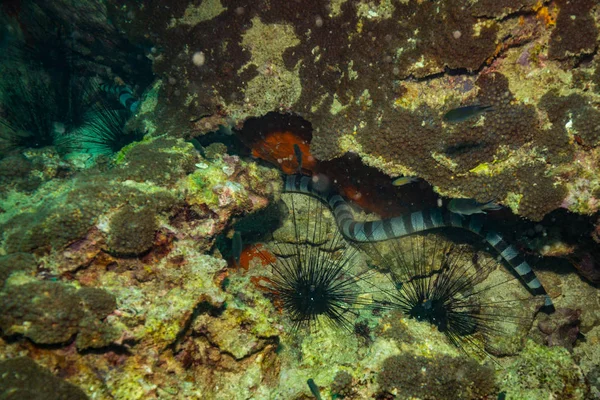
<box><xmin>500</xmin><ymin>340</ymin><xmax>588</xmax><ymax>400</ymax></box>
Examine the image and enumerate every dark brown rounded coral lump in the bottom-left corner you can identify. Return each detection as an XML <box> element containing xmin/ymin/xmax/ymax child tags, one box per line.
<box><xmin>0</xmin><ymin>357</ymin><xmax>88</xmax><ymax>400</ymax></box>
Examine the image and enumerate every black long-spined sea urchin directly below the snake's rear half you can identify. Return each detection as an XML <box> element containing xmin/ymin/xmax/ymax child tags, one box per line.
<box><xmin>376</xmin><ymin>236</ymin><xmax>541</xmax><ymax>357</ymax></box>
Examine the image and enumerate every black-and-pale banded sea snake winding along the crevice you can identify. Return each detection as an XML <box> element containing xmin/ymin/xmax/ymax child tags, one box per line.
<box><xmin>284</xmin><ymin>174</ymin><xmax>554</xmax><ymax>311</ymax></box>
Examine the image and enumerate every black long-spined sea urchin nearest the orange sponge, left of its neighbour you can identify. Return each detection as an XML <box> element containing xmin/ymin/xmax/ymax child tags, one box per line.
<box><xmin>263</xmin><ymin>195</ymin><xmax>366</xmax><ymax>331</ymax></box>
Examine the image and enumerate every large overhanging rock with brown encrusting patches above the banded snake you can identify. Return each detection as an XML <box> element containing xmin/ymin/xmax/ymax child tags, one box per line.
<box><xmin>109</xmin><ymin>0</ymin><xmax>598</xmax><ymax>220</ymax></box>
